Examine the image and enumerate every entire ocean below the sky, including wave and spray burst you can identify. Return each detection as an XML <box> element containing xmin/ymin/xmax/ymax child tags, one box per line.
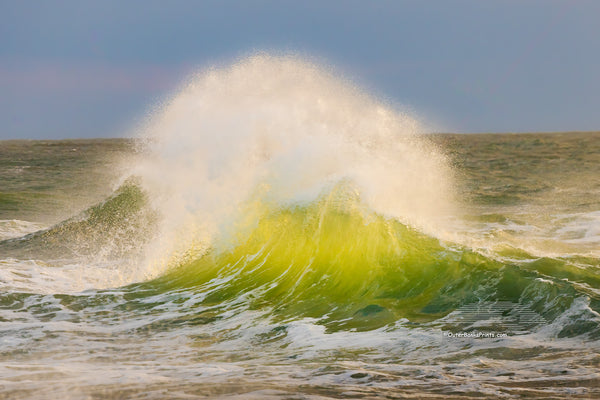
<box><xmin>0</xmin><ymin>55</ymin><xmax>600</xmax><ymax>399</ymax></box>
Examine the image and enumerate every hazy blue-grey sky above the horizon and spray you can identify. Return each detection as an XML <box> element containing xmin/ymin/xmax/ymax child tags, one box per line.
<box><xmin>0</xmin><ymin>0</ymin><xmax>600</xmax><ymax>139</ymax></box>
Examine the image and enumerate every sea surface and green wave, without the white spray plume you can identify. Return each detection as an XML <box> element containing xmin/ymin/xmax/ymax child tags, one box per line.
<box><xmin>0</xmin><ymin>133</ymin><xmax>600</xmax><ymax>399</ymax></box>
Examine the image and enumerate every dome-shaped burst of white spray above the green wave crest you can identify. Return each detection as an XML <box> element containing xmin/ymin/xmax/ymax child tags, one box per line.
<box><xmin>134</xmin><ymin>54</ymin><xmax>452</xmax><ymax>268</ymax></box>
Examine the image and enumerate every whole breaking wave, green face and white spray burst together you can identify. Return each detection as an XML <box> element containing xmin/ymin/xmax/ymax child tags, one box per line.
<box><xmin>0</xmin><ymin>54</ymin><xmax>600</xmax><ymax>335</ymax></box>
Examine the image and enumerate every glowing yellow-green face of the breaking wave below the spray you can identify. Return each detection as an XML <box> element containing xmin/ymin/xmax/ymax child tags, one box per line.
<box><xmin>148</xmin><ymin>184</ymin><xmax>599</xmax><ymax>334</ymax></box>
